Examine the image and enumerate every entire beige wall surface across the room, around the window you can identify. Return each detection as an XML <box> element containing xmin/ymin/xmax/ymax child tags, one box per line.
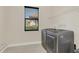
<box><xmin>0</xmin><ymin>6</ymin><xmax>79</xmax><ymax>48</ymax></box>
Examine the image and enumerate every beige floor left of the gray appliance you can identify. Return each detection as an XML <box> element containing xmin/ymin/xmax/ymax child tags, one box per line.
<box><xmin>3</xmin><ymin>44</ymin><xmax>46</xmax><ymax>53</ymax></box>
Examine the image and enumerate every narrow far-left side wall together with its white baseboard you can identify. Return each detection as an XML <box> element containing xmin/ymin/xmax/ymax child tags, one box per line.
<box><xmin>0</xmin><ymin>6</ymin><xmax>7</xmax><ymax>52</ymax></box>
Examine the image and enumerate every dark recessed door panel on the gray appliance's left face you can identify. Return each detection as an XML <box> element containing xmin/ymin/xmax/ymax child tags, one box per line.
<box><xmin>46</xmin><ymin>34</ymin><xmax>57</xmax><ymax>53</ymax></box>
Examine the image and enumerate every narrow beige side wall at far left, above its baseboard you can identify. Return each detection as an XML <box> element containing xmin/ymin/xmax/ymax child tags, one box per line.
<box><xmin>0</xmin><ymin>6</ymin><xmax>6</xmax><ymax>42</ymax></box>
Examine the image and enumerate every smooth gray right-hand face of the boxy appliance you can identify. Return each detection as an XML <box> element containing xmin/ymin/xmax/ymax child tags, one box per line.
<box><xmin>58</xmin><ymin>33</ymin><xmax>74</xmax><ymax>53</ymax></box>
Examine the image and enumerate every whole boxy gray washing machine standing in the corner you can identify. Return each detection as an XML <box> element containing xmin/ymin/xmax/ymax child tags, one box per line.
<box><xmin>42</xmin><ymin>28</ymin><xmax>74</xmax><ymax>53</ymax></box>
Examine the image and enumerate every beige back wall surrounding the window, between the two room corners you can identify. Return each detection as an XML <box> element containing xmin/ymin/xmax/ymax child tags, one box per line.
<box><xmin>5</xmin><ymin>6</ymin><xmax>51</xmax><ymax>45</ymax></box>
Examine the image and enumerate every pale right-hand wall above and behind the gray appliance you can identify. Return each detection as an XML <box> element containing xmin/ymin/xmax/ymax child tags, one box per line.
<box><xmin>50</xmin><ymin>7</ymin><xmax>79</xmax><ymax>48</ymax></box>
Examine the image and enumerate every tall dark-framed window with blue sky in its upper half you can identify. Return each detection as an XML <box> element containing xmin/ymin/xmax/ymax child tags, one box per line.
<box><xmin>24</xmin><ymin>6</ymin><xmax>39</xmax><ymax>31</ymax></box>
